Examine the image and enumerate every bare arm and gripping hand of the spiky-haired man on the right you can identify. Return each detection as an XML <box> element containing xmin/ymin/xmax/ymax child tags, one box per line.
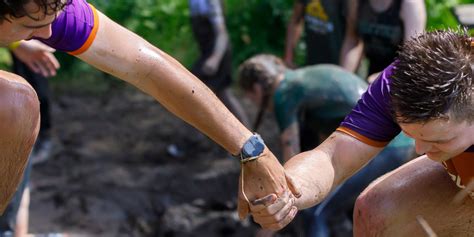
<box><xmin>251</xmin><ymin>132</ymin><xmax>382</xmax><ymax>230</ymax></box>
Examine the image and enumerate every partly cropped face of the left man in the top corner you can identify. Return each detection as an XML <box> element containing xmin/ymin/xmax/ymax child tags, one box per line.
<box><xmin>0</xmin><ymin>1</ymin><xmax>56</xmax><ymax>46</ymax></box>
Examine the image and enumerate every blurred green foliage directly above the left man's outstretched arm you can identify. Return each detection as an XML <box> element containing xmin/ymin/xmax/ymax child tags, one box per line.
<box><xmin>89</xmin><ymin>0</ymin><xmax>197</xmax><ymax>66</ymax></box>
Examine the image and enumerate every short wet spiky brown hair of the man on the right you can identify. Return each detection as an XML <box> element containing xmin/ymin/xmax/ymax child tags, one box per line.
<box><xmin>390</xmin><ymin>29</ymin><xmax>474</xmax><ymax>123</ymax></box>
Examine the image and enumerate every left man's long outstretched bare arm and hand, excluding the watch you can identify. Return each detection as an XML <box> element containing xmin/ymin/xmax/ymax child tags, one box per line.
<box><xmin>78</xmin><ymin>12</ymin><xmax>297</xmax><ymax>217</ymax></box>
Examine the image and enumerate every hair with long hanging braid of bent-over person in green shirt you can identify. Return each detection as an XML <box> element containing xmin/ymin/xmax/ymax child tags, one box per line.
<box><xmin>237</xmin><ymin>54</ymin><xmax>286</xmax><ymax>131</ymax></box>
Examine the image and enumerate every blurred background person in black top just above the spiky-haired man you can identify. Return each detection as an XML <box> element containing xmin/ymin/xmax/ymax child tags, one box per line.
<box><xmin>340</xmin><ymin>0</ymin><xmax>426</xmax><ymax>82</ymax></box>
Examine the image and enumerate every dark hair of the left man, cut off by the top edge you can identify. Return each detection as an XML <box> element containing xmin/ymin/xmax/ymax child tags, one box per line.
<box><xmin>0</xmin><ymin>0</ymin><xmax>71</xmax><ymax>23</ymax></box>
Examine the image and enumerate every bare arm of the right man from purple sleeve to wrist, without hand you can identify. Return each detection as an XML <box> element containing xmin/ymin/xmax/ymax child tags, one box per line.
<box><xmin>284</xmin><ymin>132</ymin><xmax>381</xmax><ymax>209</ymax></box>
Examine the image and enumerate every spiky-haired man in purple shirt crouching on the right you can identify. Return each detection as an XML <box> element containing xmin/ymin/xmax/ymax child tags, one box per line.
<box><xmin>251</xmin><ymin>30</ymin><xmax>474</xmax><ymax>236</ymax></box>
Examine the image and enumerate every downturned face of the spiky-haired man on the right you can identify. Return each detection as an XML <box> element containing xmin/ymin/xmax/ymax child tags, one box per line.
<box><xmin>400</xmin><ymin>116</ymin><xmax>474</xmax><ymax>162</ymax></box>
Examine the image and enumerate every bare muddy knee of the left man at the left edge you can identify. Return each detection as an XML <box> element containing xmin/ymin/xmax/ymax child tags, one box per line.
<box><xmin>0</xmin><ymin>71</ymin><xmax>40</xmax><ymax>213</ymax></box>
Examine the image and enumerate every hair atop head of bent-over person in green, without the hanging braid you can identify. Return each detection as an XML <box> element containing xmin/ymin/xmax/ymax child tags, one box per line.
<box><xmin>237</xmin><ymin>54</ymin><xmax>286</xmax><ymax>91</ymax></box>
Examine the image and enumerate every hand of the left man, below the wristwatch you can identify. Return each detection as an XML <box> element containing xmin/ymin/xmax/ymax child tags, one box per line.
<box><xmin>238</xmin><ymin>148</ymin><xmax>301</xmax><ymax>219</ymax></box>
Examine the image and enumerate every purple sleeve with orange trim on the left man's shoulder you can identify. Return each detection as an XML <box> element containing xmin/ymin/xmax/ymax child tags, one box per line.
<box><xmin>39</xmin><ymin>0</ymin><xmax>99</xmax><ymax>55</ymax></box>
